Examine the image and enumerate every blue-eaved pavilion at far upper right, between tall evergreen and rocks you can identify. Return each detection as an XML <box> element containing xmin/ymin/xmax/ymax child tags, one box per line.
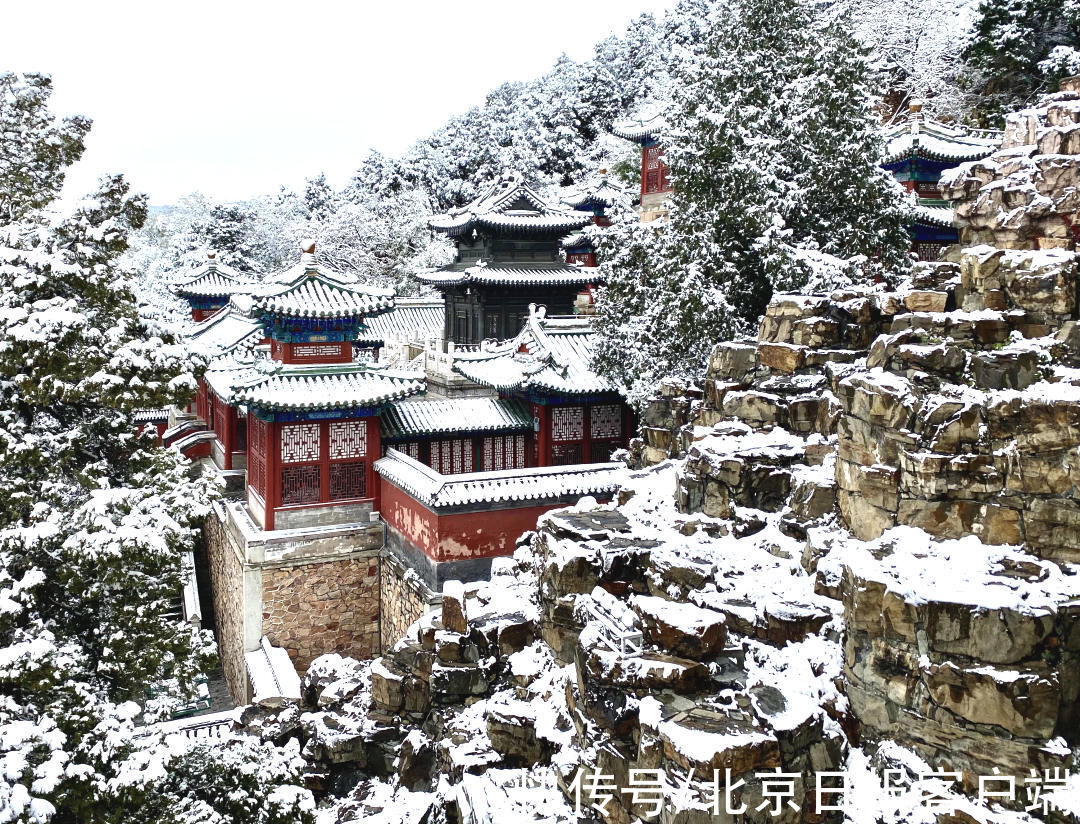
<box><xmin>882</xmin><ymin>103</ymin><xmax>1001</xmax><ymax>260</ymax></box>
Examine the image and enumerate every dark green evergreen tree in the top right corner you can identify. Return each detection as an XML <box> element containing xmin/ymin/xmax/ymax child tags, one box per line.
<box><xmin>964</xmin><ymin>0</ymin><xmax>1080</xmax><ymax>126</ymax></box>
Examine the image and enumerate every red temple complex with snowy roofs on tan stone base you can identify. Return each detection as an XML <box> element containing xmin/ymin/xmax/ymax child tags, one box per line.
<box><xmin>169</xmin><ymin>239</ymin><xmax>631</xmax><ymax>700</ymax></box>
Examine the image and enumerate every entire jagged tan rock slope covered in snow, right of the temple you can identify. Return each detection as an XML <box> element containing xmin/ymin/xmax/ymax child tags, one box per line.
<box><xmin>221</xmin><ymin>85</ymin><xmax>1080</xmax><ymax>824</ymax></box>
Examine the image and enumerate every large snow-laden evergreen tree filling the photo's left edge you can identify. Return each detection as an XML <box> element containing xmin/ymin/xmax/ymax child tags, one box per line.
<box><xmin>0</xmin><ymin>76</ymin><xmax>221</xmax><ymax>822</ymax></box>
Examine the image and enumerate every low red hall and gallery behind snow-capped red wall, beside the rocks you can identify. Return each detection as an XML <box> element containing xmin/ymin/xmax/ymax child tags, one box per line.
<box><xmin>376</xmin><ymin>306</ymin><xmax>634</xmax><ymax>587</ymax></box>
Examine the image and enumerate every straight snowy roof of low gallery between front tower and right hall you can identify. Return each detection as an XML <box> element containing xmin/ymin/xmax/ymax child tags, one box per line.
<box><xmin>380</xmin><ymin>397</ymin><xmax>532</xmax><ymax>437</ymax></box>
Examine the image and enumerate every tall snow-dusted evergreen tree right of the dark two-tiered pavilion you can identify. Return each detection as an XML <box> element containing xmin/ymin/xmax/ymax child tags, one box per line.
<box><xmin>597</xmin><ymin>0</ymin><xmax>909</xmax><ymax>399</ymax></box>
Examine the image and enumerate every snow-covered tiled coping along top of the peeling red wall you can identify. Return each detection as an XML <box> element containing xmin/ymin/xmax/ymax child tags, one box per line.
<box><xmin>375</xmin><ymin>449</ymin><xmax>627</xmax><ymax>509</ymax></box>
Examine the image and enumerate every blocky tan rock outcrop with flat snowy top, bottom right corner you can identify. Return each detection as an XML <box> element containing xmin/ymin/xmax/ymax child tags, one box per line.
<box><xmin>818</xmin><ymin>529</ymin><xmax>1080</xmax><ymax>787</ymax></box>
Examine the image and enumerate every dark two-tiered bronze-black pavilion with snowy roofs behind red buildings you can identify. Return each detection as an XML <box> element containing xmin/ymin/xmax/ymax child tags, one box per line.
<box><xmin>418</xmin><ymin>175</ymin><xmax>597</xmax><ymax>346</ymax></box>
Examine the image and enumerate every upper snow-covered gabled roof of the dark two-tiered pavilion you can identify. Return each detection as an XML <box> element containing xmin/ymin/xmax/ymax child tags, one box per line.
<box><xmin>429</xmin><ymin>174</ymin><xmax>592</xmax><ymax>238</ymax></box>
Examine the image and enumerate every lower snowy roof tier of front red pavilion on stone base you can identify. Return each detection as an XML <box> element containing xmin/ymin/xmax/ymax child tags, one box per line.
<box><xmin>236</xmin><ymin>361</ymin><xmax>426</xmax><ymax>411</ymax></box>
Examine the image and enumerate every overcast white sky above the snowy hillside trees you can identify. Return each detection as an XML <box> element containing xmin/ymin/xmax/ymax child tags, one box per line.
<box><xmin>6</xmin><ymin>0</ymin><xmax>672</xmax><ymax>204</ymax></box>
